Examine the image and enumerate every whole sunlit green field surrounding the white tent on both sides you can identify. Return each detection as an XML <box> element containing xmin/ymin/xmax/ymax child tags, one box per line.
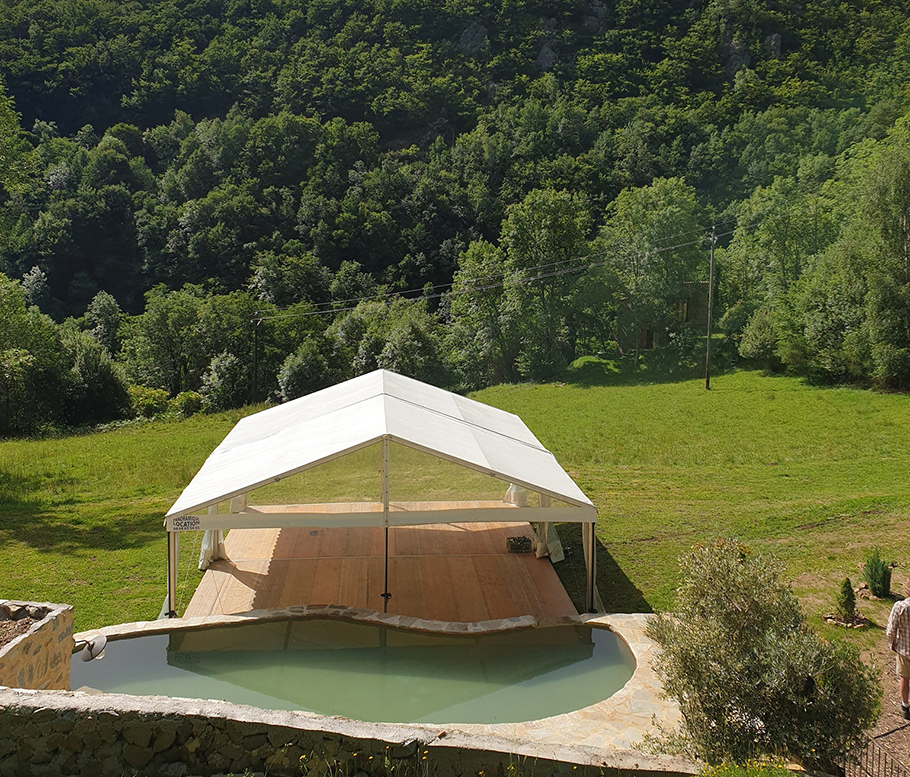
<box><xmin>0</xmin><ymin>361</ymin><xmax>910</xmax><ymax>642</ymax></box>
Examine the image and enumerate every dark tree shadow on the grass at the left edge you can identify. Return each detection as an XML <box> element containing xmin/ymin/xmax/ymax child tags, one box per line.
<box><xmin>0</xmin><ymin>471</ymin><xmax>164</xmax><ymax>553</ymax></box>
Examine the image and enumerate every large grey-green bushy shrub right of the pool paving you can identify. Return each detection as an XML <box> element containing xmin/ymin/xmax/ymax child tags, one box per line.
<box><xmin>648</xmin><ymin>540</ymin><xmax>880</xmax><ymax>769</ymax></box>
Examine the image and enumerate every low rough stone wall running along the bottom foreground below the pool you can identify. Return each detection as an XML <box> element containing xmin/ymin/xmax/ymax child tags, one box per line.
<box><xmin>0</xmin><ymin>689</ymin><xmax>698</xmax><ymax>777</ymax></box>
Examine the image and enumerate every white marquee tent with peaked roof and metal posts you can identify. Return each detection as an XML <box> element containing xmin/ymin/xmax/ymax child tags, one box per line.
<box><xmin>165</xmin><ymin>370</ymin><xmax>597</xmax><ymax>617</ymax></box>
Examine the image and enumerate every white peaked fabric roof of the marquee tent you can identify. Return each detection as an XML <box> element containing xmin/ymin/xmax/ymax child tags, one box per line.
<box><xmin>167</xmin><ymin>370</ymin><xmax>593</xmax><ymax>517</ymax></box>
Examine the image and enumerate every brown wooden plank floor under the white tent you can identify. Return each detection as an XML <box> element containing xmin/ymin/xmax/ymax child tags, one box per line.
<box><xmin>183</xmin><ymin>522</ymin><xmax>577</xmax><ymax>623</ymax></box>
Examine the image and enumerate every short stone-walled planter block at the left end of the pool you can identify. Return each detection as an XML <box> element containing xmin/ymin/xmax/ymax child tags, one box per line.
<box><xmin>0</xmin><ymin>600</ymin><xmax>73</xmax><ymax>691</ymax></box>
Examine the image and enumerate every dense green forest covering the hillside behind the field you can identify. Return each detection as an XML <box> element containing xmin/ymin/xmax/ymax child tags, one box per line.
<box><xmin>0</xmin><ymin>0</ymin><xmax>910</xmax><ymax>435</ymax></box>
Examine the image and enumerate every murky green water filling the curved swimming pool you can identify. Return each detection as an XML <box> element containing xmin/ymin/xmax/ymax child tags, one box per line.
<box><xmin>71</xmin><ymin>620</ymin><xmax>635</xmax><ymax>723</ymax></box>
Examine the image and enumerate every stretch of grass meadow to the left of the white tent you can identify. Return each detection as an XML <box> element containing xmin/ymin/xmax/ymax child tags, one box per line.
<box><xmin>0</xmin><ymin>413</ymin><xmax>249</xmax><ymax>630</ymax></box>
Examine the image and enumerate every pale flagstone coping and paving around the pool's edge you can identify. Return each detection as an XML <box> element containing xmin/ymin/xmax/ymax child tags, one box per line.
<box><xmin>75</xmin><ymin>605</ymin><xmax>684</xmax><ymax>760</ymax></box>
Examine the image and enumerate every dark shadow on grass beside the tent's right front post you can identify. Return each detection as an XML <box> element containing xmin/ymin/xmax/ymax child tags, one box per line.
<box><xmin>553</xmin><ymin>523</ymin><xmax>654</xmax><ymax>613</ymax></box>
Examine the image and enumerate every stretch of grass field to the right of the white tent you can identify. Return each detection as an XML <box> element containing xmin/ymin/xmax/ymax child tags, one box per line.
<box><xmin>478</xmin><ymin>365</ymin><xmax>910</xmax><ymax>642</ymax></box>
